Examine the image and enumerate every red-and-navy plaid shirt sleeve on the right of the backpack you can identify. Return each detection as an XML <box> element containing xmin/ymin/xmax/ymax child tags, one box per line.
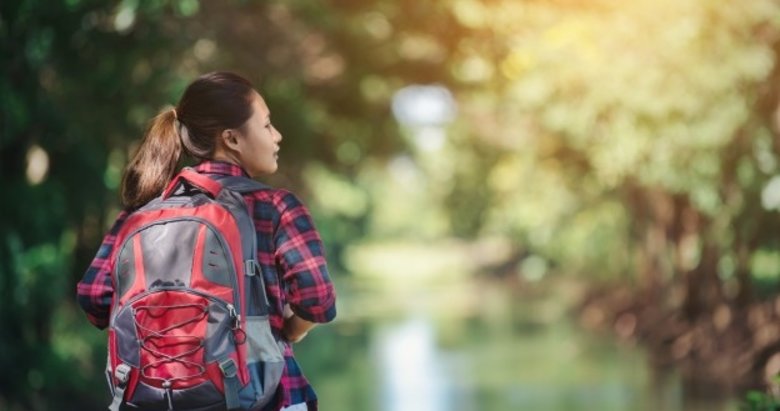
<box><xmin>274</xmin><ymin>192</ymin><xmax>336</xmax><ymax>323</ymax></box>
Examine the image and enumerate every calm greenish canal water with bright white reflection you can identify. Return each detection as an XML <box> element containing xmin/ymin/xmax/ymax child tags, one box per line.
<box><xmin>296</xmin><ymin>280</ymin><xmax>739</xmax><ymax>411</ymax></box>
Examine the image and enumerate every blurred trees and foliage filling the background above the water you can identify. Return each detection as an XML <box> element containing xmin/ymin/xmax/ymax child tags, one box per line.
<box><xmin>0</xmin><ymin>0</ymin><xmax>780</xmax><ymax>410</ymax></box>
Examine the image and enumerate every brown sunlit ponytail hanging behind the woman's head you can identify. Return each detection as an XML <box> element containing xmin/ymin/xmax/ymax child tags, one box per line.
<box><xmin>121</xmin><ymin>109</ymin><xmax>182</xmax><ymax>209</ymax></box>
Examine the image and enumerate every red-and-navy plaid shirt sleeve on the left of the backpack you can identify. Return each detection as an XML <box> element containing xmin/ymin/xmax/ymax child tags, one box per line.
<box><xmin>76</xmin><ymin>211</ymin><xmax>129</xmax><ymax>330</ymax></box>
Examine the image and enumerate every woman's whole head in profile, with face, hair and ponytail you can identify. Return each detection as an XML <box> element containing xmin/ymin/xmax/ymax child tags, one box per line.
<box><xmin>122</xmin><ymin>72</ymin><xmax>281</xmax><ymax>208</ymax></box>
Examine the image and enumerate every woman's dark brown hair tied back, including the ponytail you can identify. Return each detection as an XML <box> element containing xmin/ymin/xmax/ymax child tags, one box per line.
<box><xmin>121</xmin><ymin>72</ymin><xmax>254</xmax><ymax>208</ymax></box>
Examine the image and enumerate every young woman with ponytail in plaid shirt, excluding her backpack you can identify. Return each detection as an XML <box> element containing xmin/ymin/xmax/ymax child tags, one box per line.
<box><xmin>78</xmin><ymin>72</ymin><xmax>336</xmax><ymax>411</ymax></box>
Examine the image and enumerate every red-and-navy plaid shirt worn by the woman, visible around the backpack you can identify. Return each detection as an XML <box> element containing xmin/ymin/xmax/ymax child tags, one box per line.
<box><xmin>77</xmin><ymin>161</ymin><xmax>336</xmax><ymax>411</ymax></box>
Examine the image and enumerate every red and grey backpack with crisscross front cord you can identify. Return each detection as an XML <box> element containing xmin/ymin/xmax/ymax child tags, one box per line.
<box><xmin>106</xmin><ymin>168</ymin><xmax>284</xmax><ymax>411</ymax></box>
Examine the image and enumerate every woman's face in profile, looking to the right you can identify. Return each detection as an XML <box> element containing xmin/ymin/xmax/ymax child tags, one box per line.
<box><xmin>236</xmin><ymin>92</ymin><xmax>282</xmax><ymax>177</ymax></box>
